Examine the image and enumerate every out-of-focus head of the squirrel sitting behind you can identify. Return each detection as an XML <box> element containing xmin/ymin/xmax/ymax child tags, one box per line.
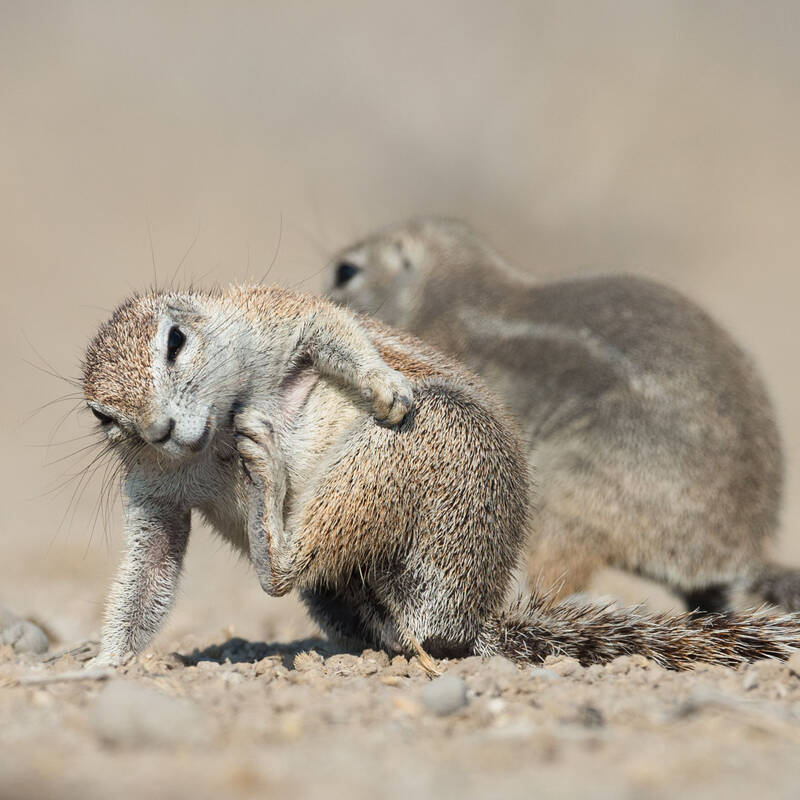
<box><xmin>325</xmin><ymin>217</ymin><xmax>496</xmax><ymax>328</ymax></box>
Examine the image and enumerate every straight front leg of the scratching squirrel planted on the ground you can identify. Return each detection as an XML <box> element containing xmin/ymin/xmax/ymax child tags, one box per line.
<box><xmin>98</xmin><ymin>496</ymin><xmax>190</xmax><ymax>664</ymax></box>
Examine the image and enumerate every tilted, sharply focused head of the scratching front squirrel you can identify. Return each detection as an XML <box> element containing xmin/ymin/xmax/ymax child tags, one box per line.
<box><xmin>83</xmin><ymin>293</ymin><xmax>244</xmax><ymax>460</ymax></box>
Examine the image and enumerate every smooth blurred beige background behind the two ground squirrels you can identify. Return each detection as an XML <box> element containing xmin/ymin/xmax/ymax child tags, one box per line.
<box><xmin>0</xmin><ymin>0</ymin><xmax>800</xmax><ymax>642</ymax></box>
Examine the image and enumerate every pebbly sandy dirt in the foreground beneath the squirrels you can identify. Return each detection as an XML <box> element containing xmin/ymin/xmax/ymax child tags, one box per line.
<box><xmin>0</xmin><ymin>638</ymin><xmax>800</xmax><ymax>800</ymax></box>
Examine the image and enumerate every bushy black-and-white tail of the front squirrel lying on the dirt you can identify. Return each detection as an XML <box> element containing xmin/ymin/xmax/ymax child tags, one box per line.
<box><xmin>475</xmin><ymin>595</ymin><xmax>800</xmax><ymax>669</ymax></box>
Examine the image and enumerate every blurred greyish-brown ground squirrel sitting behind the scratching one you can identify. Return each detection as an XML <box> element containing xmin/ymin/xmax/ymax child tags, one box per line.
<box><xmin>327</xmin><ymin>218</ymin><xmax>800</xmax><ymax>611</ymax></box>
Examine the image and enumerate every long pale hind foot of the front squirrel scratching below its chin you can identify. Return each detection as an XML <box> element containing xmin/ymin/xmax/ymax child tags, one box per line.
<box><xmin>234</xmin><ymin>408</ymin><xmax>297</xmax><ymax>597</ymax></box>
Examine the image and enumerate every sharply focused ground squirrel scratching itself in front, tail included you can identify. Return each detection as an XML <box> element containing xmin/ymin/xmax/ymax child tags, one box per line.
<box><xmin>83</xmin><ymin>287</ymin><xmax>800</xmax><ymax>669</ymax></box>
